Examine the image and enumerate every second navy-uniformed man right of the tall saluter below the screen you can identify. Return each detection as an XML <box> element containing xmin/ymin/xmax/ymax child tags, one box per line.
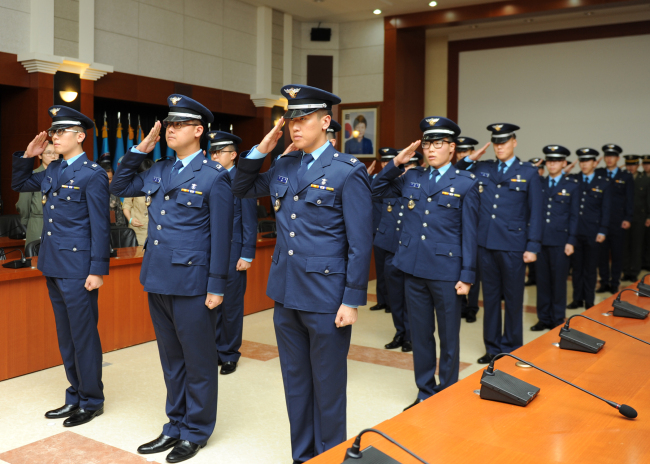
<box><xmin>567</xmin><ymin>148</ymin><xmax>611</xmax><ymax>309</ymax></box>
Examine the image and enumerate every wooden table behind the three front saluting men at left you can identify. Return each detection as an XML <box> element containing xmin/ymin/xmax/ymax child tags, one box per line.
<box><xmin>0</xmin><ymin>234</ymin><xmax>276</xmax><ymax>381</ymax></box>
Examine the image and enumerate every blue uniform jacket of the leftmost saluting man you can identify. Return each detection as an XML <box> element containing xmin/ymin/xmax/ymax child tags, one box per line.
<box><xmin>11</xmin><ymin>152</ymin><xmax>110</xmax><ymax>279</ymax></box>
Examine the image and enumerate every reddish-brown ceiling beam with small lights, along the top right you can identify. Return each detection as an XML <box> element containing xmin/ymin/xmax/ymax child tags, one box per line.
<box><xmin>384</xmin><ymin>0</ymin><xmax>647</xmax><ymax>29</ymax></box>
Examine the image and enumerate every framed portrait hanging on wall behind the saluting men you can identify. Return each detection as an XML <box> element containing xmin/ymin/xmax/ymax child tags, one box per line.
<box><xmin>340</xmin><ymin>105</ymin><xmax>379</xmax><ymax>158</ymax></box>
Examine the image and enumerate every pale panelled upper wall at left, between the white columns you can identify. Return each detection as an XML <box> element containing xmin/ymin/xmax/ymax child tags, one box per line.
<box><xmin>95</xmin><ymin>0</ymin><xmax>257</xmax><ymax>94</ymax></box>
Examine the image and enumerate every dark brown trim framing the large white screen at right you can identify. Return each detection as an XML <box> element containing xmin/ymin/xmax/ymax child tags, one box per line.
<box><xmin>447</xmin><ymin>21</ymin><xmax>650</xmax><ymax>121</ymax></box>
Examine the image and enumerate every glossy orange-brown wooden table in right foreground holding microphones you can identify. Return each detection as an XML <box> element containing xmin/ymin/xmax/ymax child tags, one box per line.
<box><xmin>309</xmin><ymin>284</ymin><xmax>650</xmax><ymax>464</ymax></box>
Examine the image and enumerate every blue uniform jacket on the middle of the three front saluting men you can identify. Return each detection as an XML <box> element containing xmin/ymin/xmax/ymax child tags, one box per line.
<box><xmin>111</xmin><ymin>151</ymin><xmax>234</xmax><ymax>296</ymax></box>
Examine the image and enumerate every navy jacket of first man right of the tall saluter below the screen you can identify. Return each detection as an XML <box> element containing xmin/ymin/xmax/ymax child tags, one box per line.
<box><xmin>542</xmin><ymin>175</ymin><xmax>581</xmax><ymax>246</ymax></box>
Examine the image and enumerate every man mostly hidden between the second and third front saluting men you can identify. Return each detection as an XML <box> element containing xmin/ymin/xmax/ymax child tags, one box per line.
<box><xmin>208</xmin><ymin>131</ymin><xmax>257</xmax><ymax>375</ymax></box>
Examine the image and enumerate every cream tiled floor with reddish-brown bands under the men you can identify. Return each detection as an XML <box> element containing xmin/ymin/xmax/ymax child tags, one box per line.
<box><xmin>0</xmin><ymin>281</ymin><xmax>609</xmax><ymax>464</ymax></box>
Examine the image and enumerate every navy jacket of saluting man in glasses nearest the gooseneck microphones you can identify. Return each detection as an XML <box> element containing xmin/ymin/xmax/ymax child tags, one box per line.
<box><xmin>373</xmin><ymin>162</ymin><xmax>479</xmax><ymax>284</ymax></box>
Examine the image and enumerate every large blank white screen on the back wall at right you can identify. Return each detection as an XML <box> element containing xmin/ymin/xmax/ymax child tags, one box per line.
<box><xmin>458</xmin><ymin>35</ymin><xmax>650</xmax><ymax>160</ymax></box>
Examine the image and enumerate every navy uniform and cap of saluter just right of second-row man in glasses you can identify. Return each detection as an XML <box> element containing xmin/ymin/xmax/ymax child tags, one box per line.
<box><xmin>456</xmin><ymin>123</ymin><xmax>542</xmax><ymax>363</ymax></box>
